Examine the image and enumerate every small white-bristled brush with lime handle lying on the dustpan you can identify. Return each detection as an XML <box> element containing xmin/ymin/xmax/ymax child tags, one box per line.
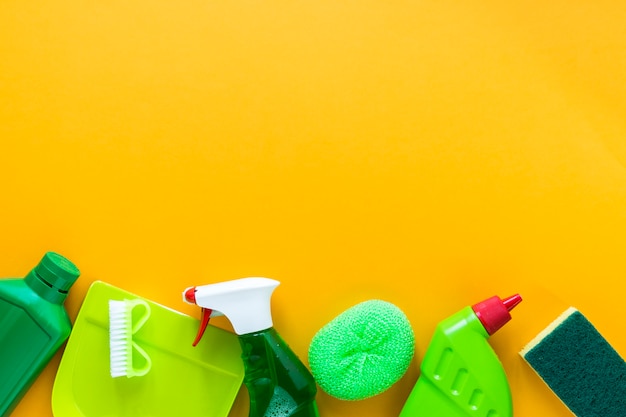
<box><xmin>109</xmin><ymin>299</ymin><xmax>152</xmax><ymax>378</ymax></box>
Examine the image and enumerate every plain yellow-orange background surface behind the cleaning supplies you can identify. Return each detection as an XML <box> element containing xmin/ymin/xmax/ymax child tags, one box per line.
<box><xmin>0</xmin><ymin>0</ymin><xmax>626</xmax><ymax>417</ymax></box>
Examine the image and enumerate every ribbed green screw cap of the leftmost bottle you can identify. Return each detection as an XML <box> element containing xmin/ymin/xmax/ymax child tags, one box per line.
<box><xmin>26</xmin><ymin>252</ymin><xmax>80</xmax><ymax>303</ymax></box>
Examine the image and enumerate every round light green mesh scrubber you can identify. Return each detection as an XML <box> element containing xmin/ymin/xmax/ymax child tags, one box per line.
<box><xmin>309</xmin><ymin>300</ymin><xmax>415</xmax><ymax>400</ymax></box>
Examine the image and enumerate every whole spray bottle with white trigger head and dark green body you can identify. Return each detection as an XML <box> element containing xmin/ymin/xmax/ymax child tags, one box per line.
<box><xmin>183</xmin><ymin>277</ymin><xmax>319</xmax><ymax>417</ymax></box>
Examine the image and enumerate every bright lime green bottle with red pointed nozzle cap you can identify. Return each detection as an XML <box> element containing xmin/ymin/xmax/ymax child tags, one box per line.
<box><xmin>400</xmin><ymin>294</ymin><xmax>522</xmax><ymax>417</ymax></box>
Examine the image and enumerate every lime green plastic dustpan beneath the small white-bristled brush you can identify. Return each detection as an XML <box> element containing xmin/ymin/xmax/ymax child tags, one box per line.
<box><xmin>52</xmin><ymin>281</ymin><xmax>244</xmax><ymax>417</ymax></box>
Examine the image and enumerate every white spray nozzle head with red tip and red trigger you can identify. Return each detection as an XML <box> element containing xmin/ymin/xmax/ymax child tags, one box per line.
<box><xmin>183</xmin><ymin>277</ymin><xmax>280</xmax><ymax>340</ymax></box>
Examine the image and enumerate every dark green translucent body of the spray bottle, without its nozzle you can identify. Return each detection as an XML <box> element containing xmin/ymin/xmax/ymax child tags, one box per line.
<box><xmin>239</xmin><ymin>328</ymin><xmax>319</xmax><ymax>417</ymax></box>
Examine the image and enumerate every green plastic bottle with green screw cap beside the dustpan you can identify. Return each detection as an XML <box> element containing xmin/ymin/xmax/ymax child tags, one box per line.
<box><xmin>0</xmin><ymin>252</ymin><xmax>80</xmax><ymax>416</ymax></box>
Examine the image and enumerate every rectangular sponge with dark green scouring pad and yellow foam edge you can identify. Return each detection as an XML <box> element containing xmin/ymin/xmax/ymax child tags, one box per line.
<box><xmin>520</xmin><ymin>307</ymin><xmax>626</xmax><ymax>417</ymax></box>
